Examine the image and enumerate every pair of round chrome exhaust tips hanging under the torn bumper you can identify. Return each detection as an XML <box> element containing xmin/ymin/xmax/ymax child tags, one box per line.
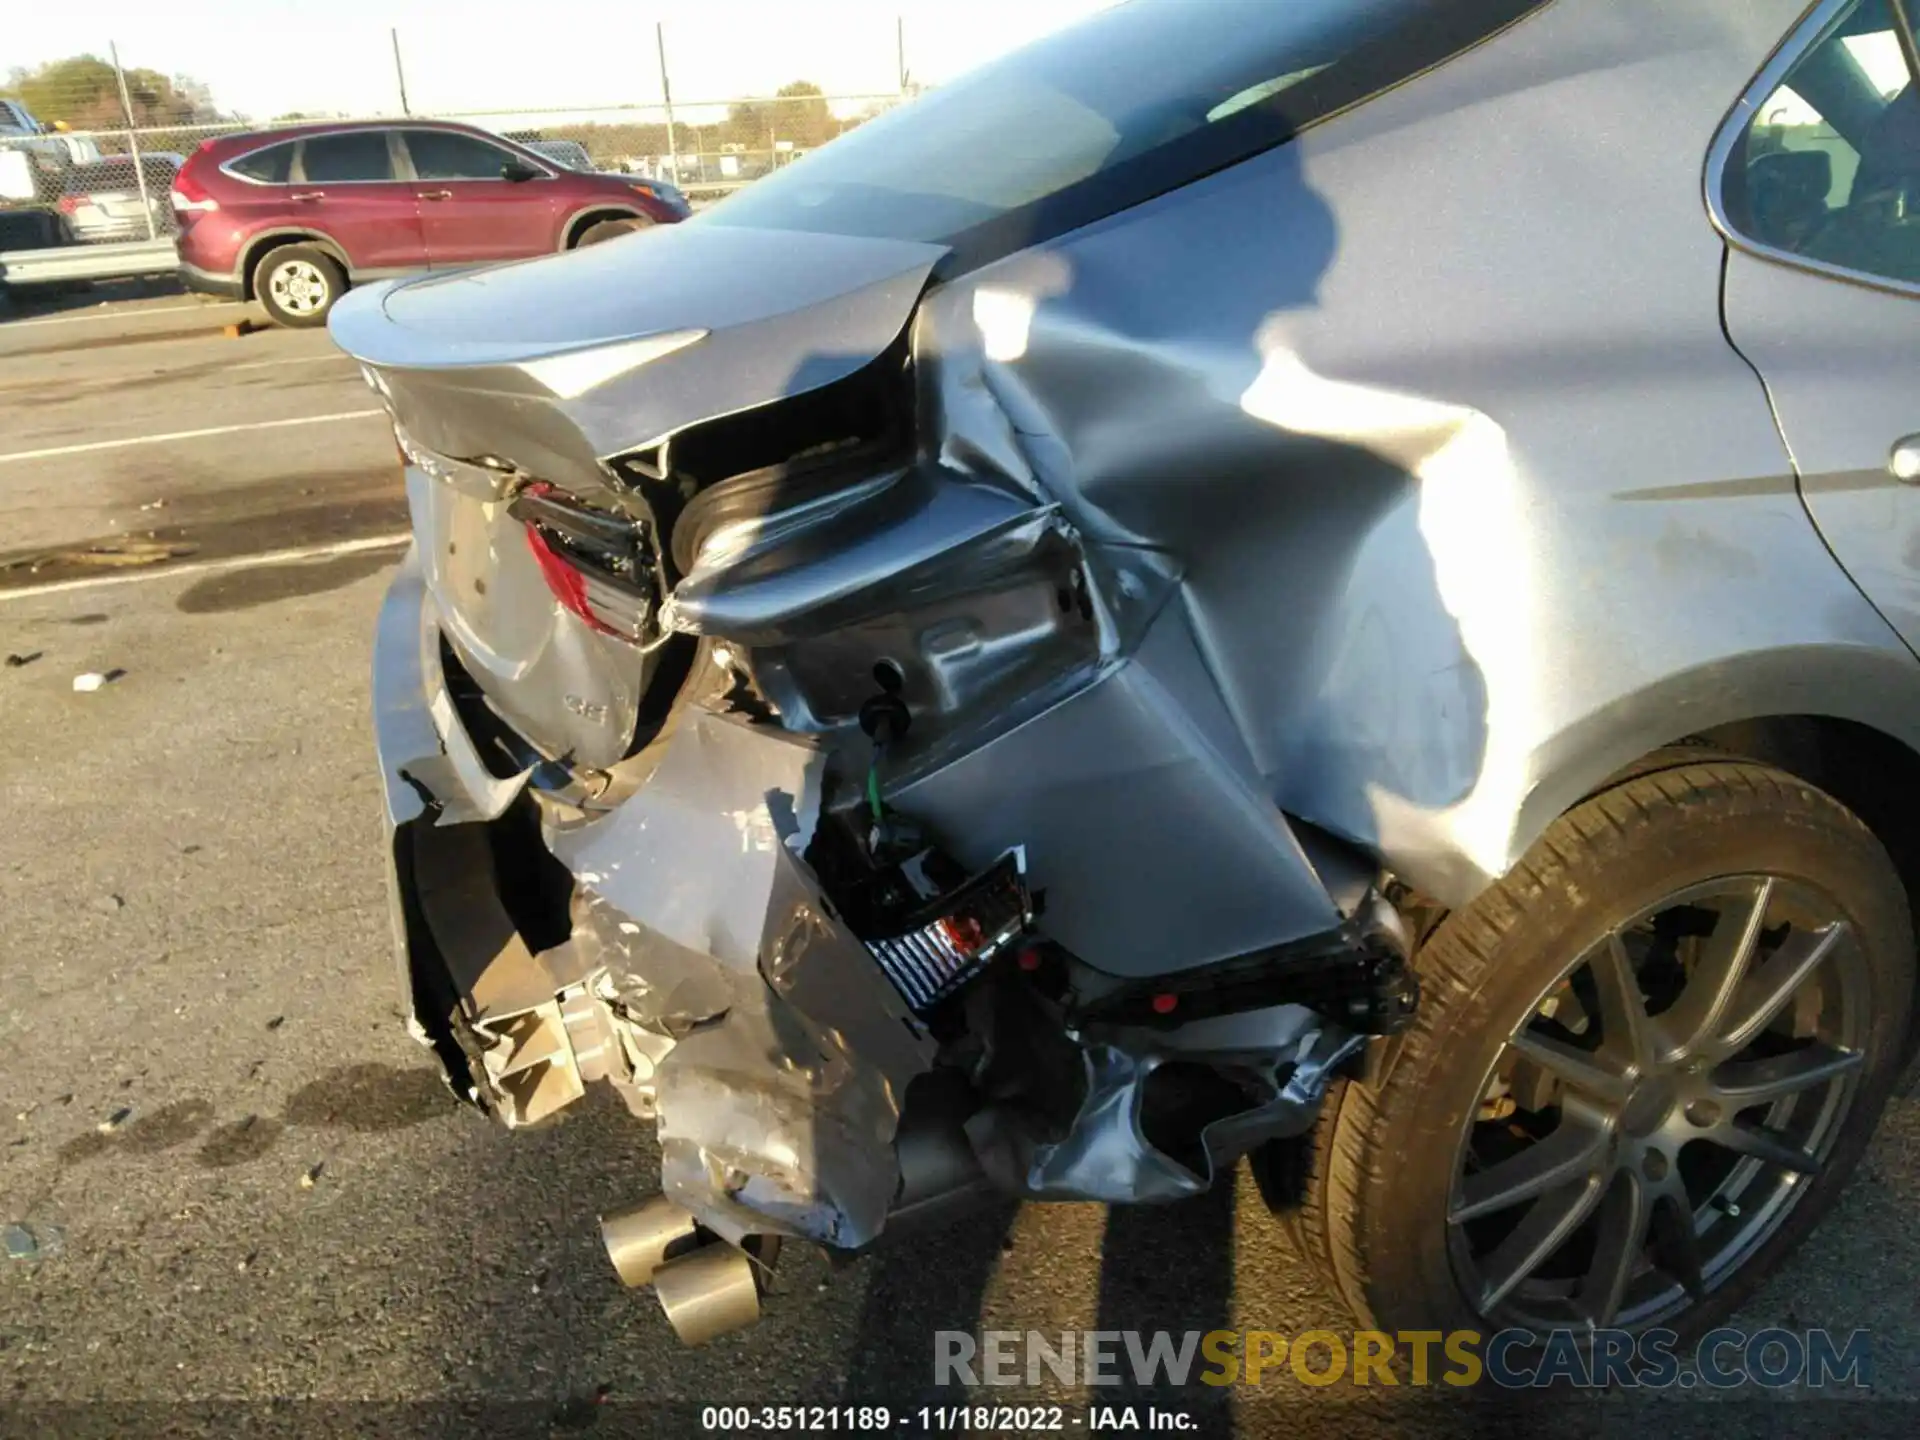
<box><xmin>601</xmin><ymin>1194</ymin><xmax>774</xmax><ymax>1346</ymax></box>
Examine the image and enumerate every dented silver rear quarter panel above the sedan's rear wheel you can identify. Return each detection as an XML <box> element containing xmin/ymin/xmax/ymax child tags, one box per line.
<box><xmin>920</xmin><ymin>2</ymin><xmax>1920</xmax><ymax>904</ymax></box>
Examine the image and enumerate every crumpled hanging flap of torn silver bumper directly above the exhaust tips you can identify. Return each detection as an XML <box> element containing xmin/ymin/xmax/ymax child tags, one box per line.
<box><xmin>553</xmin><ymin>708</ymin><xmax>933</xmax><ymax>1248</ymax></box>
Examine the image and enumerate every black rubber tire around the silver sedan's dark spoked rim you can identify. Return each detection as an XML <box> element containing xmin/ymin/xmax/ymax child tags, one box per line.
<box><xmin>1297</xmin><ymin>760</ymin><xmax>1914</xmax><ymax>1336</ymax></box>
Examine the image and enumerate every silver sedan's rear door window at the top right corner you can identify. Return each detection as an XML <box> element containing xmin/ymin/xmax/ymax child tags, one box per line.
<box><xmin>1720</xmin><ymin>0</ymin><xmax>1920</xmax><ymax>282</ymax></box>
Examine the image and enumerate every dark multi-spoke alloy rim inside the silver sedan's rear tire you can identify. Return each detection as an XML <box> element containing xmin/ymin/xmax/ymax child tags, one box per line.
<box><xmin>1448</xmin><ymin>876</ymin><xmax>1868</xmax><ymax>1331</ymax></box>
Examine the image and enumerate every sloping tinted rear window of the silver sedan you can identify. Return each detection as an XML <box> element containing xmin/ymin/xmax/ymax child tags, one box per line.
<box><xmin>699</xmin><ymin>0</ymin><xmax>1546</xmax><ymax>269</ymax></box>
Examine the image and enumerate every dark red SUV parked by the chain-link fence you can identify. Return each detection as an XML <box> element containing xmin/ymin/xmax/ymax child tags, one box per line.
<box><xmin>173</xmin><ymin>121</ymin><xmax>687</xmax><ymax>326</ymax></box>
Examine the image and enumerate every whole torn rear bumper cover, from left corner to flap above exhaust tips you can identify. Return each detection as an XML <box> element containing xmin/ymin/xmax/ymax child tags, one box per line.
<box><xmin>376</xmin><ymin>557</ymin><xmax>933</xmax><ymax>1248</ymax></box>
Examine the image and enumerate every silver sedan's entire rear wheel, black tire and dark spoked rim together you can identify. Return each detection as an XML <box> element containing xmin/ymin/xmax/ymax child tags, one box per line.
<box><xmin>1302</xmin><ymin>762</ymin><xmax>1914</xmax><ymax>1334</ymax></box>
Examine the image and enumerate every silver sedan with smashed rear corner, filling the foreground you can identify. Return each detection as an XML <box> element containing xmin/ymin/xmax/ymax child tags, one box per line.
<box><xmin>332</xmin><ymin>0</ymin><xmax>1920</xmax><ymax>1342</ymax></box>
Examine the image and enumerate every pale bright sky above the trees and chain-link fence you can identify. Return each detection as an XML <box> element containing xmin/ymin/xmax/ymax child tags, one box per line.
<box><xmin>0</xmin><ymin>0</ymin><xmax>1112</xmax><ymax>119</ymax></box>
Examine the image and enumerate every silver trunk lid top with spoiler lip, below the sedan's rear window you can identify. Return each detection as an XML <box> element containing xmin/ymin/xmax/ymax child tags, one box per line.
<box><xmin>343</xmin><ymin>221</ymin><xmax>945</xmax><ymax>486</ymax></box>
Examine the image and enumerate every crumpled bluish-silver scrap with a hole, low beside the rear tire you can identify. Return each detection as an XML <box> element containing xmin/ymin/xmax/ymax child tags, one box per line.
<box><xmin>966</xmin><ymin>1006</ymin><xmax>1365</xmax><ymax>1204</ymax></box>
